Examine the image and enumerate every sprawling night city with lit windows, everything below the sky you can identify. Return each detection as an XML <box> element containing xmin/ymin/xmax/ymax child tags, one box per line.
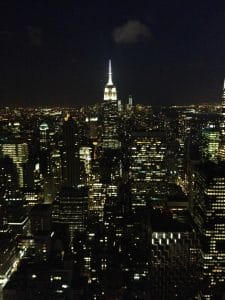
<box><xmin>0</xmin><ymin>60</ymin><xmax>225</xmax><ymax>300</ymax></box>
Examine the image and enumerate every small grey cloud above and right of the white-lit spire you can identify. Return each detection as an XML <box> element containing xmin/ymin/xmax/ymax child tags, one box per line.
<box><xmin>112</xmin><ymin>20</ymin><xmax>152</xmax><ymax>44</ymax></box>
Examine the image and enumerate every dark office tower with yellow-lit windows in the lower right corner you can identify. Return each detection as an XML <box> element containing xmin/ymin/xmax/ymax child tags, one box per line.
<box><xmin>189</xmin><ymin>162</ymin><xmax>225</xmax><ymax>299</ymax></box>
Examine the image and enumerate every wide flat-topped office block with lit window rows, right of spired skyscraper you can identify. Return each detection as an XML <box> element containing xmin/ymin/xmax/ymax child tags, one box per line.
<box><xmin>129</xmin><ymin>132</ymin><xmax>166</xmax><ymax>208</ymax></box>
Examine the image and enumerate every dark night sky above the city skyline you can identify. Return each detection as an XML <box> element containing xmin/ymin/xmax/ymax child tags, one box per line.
<box><xmin>0</xmin><ymin>0</ymin><xmax>225</xmax><ymax>106</ymax></box>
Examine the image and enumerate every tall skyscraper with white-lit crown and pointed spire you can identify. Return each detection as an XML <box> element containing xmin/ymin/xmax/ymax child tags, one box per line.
<box><xmin>102</xmin><ymin>60</ymin><xmax>121</xmax><ymax>149</ymax></box>
